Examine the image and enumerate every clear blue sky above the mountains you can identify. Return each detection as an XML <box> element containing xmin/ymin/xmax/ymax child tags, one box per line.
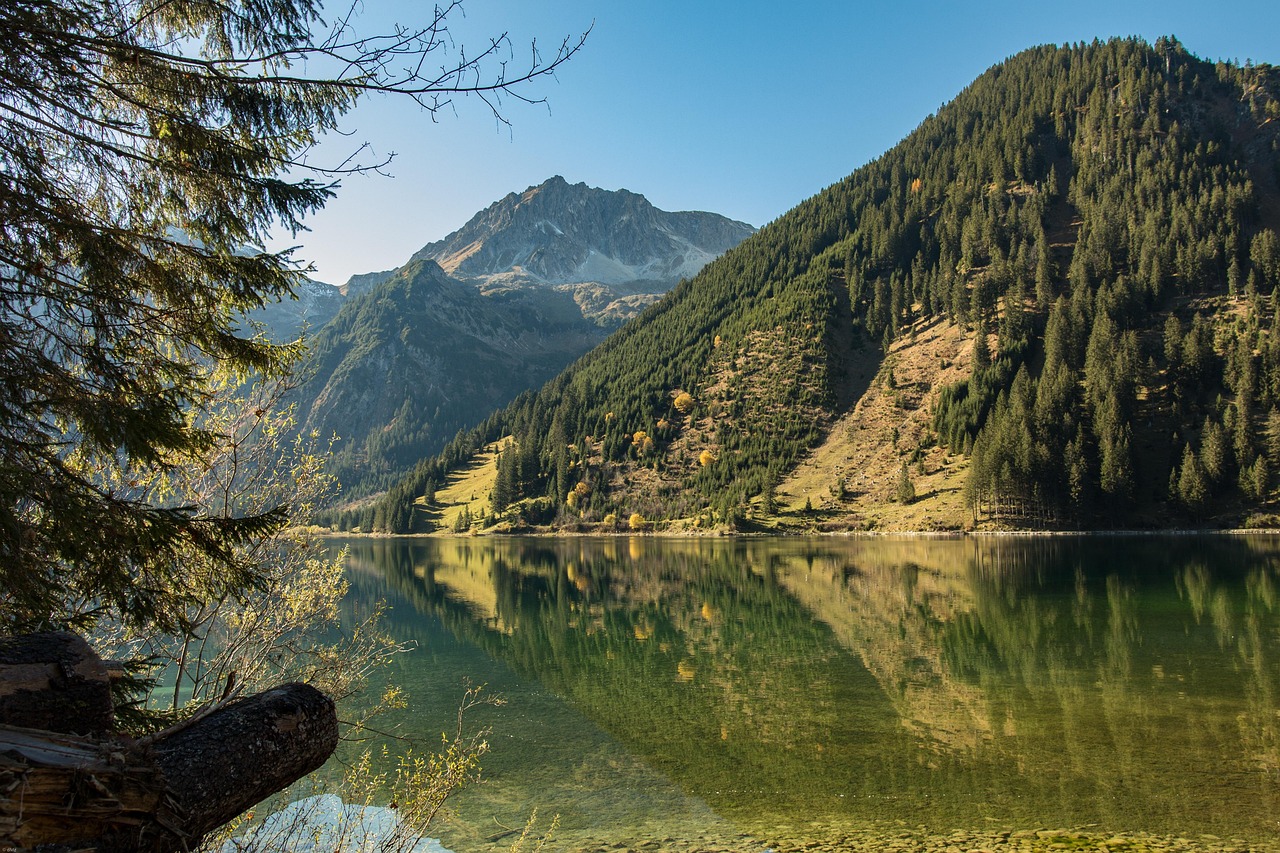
<box><xmin>275</xmin><ymin>0</ymin><xmax>1280</xmax><ymax>283</ymax></box>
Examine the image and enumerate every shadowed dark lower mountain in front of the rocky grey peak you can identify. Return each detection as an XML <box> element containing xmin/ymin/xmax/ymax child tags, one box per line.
<box><xmin>297</xmin><ymin>261</ymin><xmax>603</xmax><ymax>496</ymax></box>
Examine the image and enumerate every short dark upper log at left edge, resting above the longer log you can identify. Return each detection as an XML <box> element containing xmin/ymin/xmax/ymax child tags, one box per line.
<box><xmin>0</xmin><ymin>631</ymin><xmax>115</xmax><ymax>735</ymax></box>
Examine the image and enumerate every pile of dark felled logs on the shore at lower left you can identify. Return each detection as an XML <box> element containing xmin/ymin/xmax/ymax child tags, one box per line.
<box><xmin>0</xmin><ymin>634</ymin><xmax>338</xmax><ymax>853</ymax></box>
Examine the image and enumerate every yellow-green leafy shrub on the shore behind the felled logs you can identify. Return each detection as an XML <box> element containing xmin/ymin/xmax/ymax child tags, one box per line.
<box><xmin>90</xmin><ymin>383</ymin><xmax>397</xmax><ymax>731</ymax></box>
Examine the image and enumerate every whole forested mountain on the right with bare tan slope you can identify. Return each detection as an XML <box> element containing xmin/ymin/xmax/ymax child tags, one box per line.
<box><xmin>364</xmin><ymin>38</ymin><xmax>1280</xmax><ymax>530</ymax></box>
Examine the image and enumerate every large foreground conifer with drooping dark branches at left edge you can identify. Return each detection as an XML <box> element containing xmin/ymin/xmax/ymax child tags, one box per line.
<box><xmin>0</xmin><ymin>0</ymin><xmax>581</xmax><ymax>631</ymax></box>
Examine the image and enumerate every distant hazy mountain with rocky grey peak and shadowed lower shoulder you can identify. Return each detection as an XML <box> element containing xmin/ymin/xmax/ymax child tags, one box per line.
<box><xmin>270</xmin><ymin>178</ymin><xmax>753</xmax><ymax>498</ymax></box>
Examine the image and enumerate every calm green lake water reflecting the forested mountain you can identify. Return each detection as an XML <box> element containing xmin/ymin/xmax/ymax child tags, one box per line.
<box><xmin>332</xmin><ymin>537</ymin><xmax>1280</xmax><ymax>850</ymax></box>
